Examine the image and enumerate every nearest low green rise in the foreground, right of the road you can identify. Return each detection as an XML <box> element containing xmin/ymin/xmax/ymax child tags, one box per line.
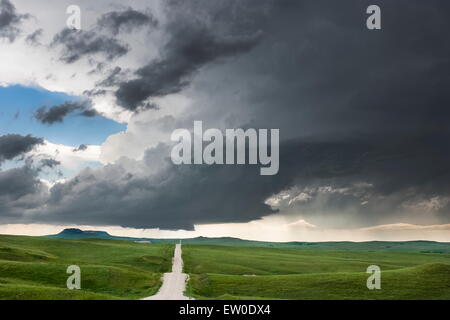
<box><xmin>189</xmin><ymin>264</ymin><xmax>450</xmax><ymax>300</ymax></box>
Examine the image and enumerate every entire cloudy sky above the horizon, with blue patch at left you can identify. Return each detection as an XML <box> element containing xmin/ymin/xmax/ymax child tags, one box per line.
<box><xmin>0</xmin><ymin>0</ymin><xmax>450</xmax><ymax>241</ymax></box>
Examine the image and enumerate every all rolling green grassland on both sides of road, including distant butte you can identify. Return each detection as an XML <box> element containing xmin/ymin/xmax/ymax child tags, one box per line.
<box><xmin>4</xmin><ymin>229</ymin><xmax>450</xmax><ymax>299</ymax></box>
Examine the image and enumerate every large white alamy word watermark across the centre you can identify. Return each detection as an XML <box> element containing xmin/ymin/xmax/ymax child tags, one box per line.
<box><xmin>171</xmin><ymin>121</ymin><xmax>280</xmax><ymax>176</ymax></box>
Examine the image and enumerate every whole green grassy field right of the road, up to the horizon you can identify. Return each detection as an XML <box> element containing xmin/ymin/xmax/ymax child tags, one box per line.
<box><xmin>183</xmin><ymin>241</ymin><xmax>450</xmax><ymax>299</ymax></box>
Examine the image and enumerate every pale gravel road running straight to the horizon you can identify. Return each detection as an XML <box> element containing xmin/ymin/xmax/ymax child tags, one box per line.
<box><xmin>142</xmin><ymin>244</ymin><xmax>193</xmax><ymax>300</ymax></box>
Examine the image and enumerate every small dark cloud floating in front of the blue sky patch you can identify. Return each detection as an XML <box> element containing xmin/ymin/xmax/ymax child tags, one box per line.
<box><xmin>34</xmin><ymin>101</ymin><xmax>98</xmax><ymax>125</ymax></box>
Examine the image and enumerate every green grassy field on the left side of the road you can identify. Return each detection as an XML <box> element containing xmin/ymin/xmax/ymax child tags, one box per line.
<box><xmin>0</xmin><ymin>235</ymin><xmax>173</xmax><ymax>299</ymax></box>
